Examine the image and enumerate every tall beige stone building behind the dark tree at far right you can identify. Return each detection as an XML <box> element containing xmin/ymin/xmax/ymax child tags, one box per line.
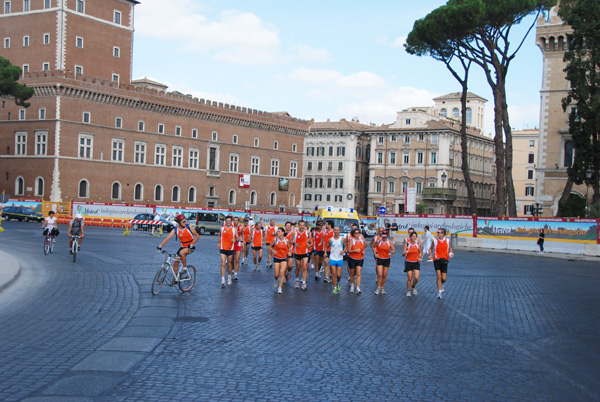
<box><xmin>535</xmin><ymin>7</ymin><xmax>586</xmax><ymax>216</ymax></box>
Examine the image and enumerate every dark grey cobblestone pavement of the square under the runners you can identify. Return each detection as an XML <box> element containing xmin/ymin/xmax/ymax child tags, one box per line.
<box><xmin>0</xmin><ymin>222</ymin><xmax>600</xmax><ymax>401</ymax></box>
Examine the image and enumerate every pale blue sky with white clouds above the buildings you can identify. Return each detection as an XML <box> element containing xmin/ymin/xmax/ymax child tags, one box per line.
<box><xmin>132</xmin><ymin>0</ymin><xmax>542</xmax><ymax>134</ymax></box>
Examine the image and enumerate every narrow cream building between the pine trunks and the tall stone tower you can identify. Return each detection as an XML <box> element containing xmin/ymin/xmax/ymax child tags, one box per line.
<box><xmin>512</xmin><ymin>129</ymin><xmax>539</xmax><ymax>216</ymax></box>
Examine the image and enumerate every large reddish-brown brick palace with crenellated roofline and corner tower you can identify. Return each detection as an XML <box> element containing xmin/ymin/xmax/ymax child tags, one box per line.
<box><xmin>0</xmin><ymin>0</ymin><xmax>309</xmax><ymax>211</ymax></box>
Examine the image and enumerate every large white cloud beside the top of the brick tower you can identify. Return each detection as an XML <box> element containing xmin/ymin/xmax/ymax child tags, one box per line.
<box><xmin>135</xmin><ymin>0</ymin><xmax>330</xmax><ymax>64</ymax></box>
